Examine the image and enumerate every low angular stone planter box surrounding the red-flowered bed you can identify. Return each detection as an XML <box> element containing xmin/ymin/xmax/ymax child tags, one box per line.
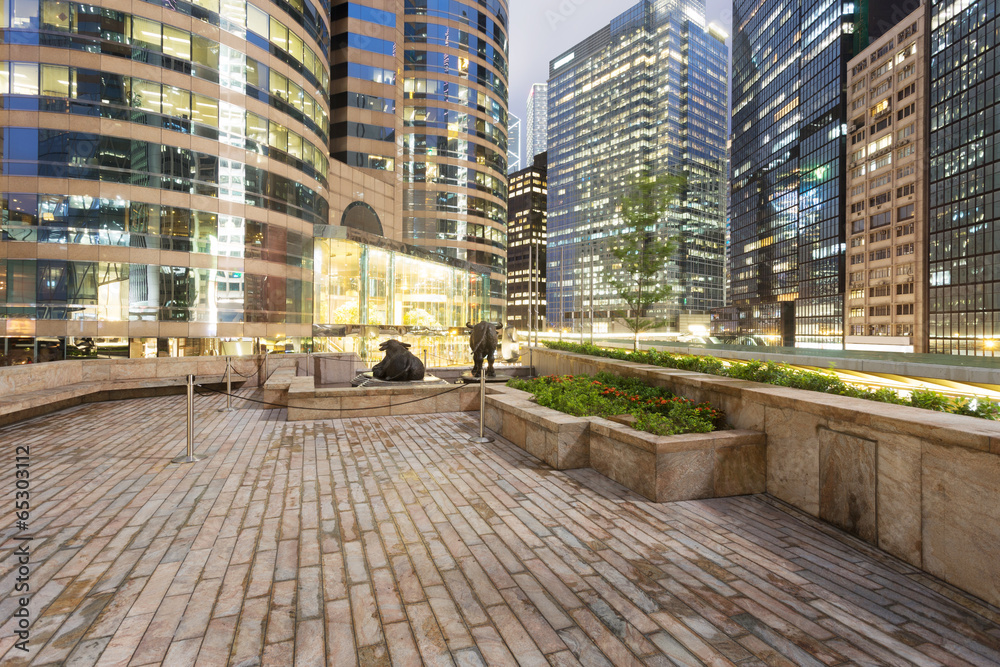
<box><xmin>486</xmin><ymin>387</ymin><xmax>767</xmax><ymax>502</ymax></box>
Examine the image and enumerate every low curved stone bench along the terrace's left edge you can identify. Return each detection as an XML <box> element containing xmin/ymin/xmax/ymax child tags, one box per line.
<box><xmin>0</xmin><ymin>375</ymin><xmax>225</xmax><ymax>426</ymax></box>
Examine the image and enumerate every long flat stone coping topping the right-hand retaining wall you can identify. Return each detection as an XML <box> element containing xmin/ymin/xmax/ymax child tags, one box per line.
<box><xmin>535</xmin><ymin>349</ymin><xmax>1000</xmax><ymax>455</ymax></box>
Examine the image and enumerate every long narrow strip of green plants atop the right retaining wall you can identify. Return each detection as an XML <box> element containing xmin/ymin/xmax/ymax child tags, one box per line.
<box><xmin>545</xmin><ymin>341</ymin><xmax>1000</xmax><ymax>420</ymax></box>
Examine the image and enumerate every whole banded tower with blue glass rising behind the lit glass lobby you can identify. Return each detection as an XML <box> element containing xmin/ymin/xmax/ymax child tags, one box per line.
<box><xmin>331</xmin><ymin>0</ymin><xmax>508</xmax><ymax>321</ymax></box>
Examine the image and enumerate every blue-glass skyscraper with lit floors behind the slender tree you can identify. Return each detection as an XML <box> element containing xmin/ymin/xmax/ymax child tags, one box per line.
<box><xmin>547</xmin><ymin>0</ymin><xmax>727</xmax><ymax>331</ymax></box>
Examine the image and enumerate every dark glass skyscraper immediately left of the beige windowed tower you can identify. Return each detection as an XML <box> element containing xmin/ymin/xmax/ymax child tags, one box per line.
<box><xmin>731</xmin><ymin>0</ymin><xmax>909</xmax><ymax>348</ymax></box>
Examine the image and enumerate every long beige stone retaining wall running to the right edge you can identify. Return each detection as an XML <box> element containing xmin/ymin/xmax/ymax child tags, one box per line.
<box><xmin>534</xmin><ymin>349</ymin><xmax>1000</xmax><ymax>605</ymax></box>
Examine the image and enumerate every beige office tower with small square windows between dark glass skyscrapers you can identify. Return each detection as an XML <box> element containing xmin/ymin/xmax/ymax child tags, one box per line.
<box><xmin>844</xmin><ymin>7</ymin><xmax>928</xmax><ymax>352</ymax></box>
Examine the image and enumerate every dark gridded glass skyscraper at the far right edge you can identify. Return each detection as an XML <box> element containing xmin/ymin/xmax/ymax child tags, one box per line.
<box><xmin>928</xmin><ymin>0</ymin><xmax>1000</xmax><ymax>356</ymax></box>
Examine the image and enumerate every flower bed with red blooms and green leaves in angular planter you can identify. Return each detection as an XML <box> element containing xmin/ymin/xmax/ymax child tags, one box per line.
<box><xmin>508</xmin><ymin>373</ymin><xmax>725</xmax><ymax>435</ymax></box>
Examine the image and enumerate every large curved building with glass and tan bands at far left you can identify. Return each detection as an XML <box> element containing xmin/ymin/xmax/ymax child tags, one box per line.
<box><xmin>0</xmin><ymin>0</ymin><xmax>330</xmax><ymax>359</ymax></box>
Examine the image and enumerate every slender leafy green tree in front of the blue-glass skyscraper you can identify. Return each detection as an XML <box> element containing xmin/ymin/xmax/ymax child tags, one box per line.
<box><xmin>608</xmin><ymin>171</ymin><xmax>686</xmax><ymax>350</ymax></box>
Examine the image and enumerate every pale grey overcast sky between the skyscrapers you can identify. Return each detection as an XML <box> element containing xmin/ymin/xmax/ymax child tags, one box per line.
<box><xmin>510</xmin><ymin>0</ymin><xmax>733</xmax><ymax>161</ymax></box>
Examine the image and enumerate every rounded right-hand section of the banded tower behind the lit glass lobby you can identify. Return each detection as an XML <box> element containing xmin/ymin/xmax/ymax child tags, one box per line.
<box><xmin>401</xmin><ymin>0</ymin><xmax>508</xmax><ymax>321</ymax></box>
